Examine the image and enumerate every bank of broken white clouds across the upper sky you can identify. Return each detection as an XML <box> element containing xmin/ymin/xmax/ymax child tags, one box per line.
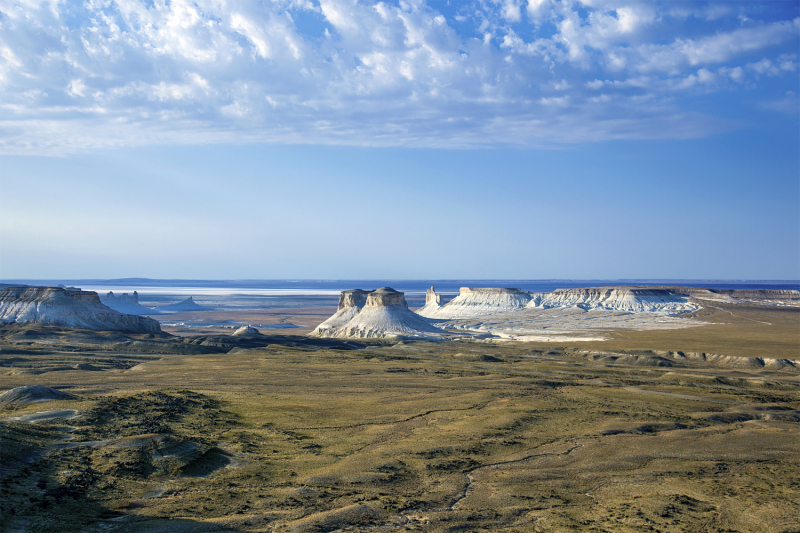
<box><xmin>0</xmin><ymin>0</ymin><xmax>800</xmax><ymax>154</ymax></box>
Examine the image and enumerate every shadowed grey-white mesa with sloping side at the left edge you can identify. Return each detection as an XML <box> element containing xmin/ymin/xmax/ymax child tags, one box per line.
<box><xmin>0</xmin><ymin>287</ymin><xmax>161</xmax><ymax>333</ymax></box>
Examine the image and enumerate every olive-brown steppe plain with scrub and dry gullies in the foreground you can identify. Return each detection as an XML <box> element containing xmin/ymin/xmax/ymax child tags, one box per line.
<box><xmin>0</xmin><ymin>303</ymin><xmax>800</xmax><ymax>533</ymax></box>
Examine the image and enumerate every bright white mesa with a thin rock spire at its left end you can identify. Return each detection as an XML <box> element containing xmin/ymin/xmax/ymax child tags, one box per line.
<box><xmin>417</xmin><ymin>287</ymin><xmax>532</xmax><ymax>319</ymax></box>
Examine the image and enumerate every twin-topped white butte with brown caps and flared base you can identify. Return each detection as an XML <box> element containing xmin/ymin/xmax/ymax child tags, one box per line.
<box><xmin>311</xmin><ymin>287</ymin><xmax>447</xmax><ymax>339</ymax></box>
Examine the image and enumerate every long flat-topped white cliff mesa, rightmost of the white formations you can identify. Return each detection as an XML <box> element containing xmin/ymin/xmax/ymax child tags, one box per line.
<box><xmin>528</xmin><ymin>286</ymin><xmax>700</xmax><ymax>315</ymax></box>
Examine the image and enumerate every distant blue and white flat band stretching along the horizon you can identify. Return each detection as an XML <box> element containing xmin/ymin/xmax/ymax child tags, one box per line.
<box><xmin>1</xmin><ymin>278</ymin><xmax>800</xmax><ymax>309</ymax></box>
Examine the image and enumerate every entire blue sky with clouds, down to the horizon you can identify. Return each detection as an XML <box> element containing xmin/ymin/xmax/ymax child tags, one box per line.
<box><xmin>0</xmin><ymin>0</ymin><xmax>800</xmax><ymax>280</ymax></box>
